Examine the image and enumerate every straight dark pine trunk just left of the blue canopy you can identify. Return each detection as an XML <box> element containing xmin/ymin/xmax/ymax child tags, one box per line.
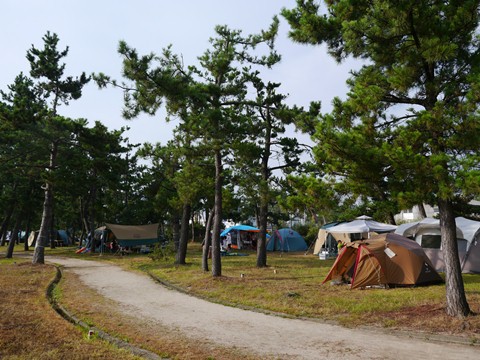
<box><xmin>212</xmin><ymin>149</ymin><xmax>223</xmax><ymax>277</ymax></box>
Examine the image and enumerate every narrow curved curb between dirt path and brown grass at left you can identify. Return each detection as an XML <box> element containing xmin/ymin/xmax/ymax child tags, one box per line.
<box><xmin>46</xmin><ymin>265</ymin><xmax>168</xmax><ymax>360</ymax></box>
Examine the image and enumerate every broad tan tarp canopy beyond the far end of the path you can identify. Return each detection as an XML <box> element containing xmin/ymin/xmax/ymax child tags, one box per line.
<box><xmin>105</xmin><ymin>223</ymin><xmax>159</xmax><ymax>246</ymax></box>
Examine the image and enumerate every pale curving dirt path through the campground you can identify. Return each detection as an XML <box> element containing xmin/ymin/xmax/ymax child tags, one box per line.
<box><xmin>46</xmin><ymin>257</ymin><xmax>480</xmax><ymax>360</ymax></box>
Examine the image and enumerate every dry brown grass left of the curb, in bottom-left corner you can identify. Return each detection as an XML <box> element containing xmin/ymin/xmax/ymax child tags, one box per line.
<box><xmin>0</xmin><ymin>260</ymin><xmax>137</xmax><ymax>359</ymax></box>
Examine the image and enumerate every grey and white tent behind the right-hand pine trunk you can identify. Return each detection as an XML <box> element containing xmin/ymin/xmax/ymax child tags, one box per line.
<box><xmin>395</xmin><ymin>217</ymin><xmax>480</xmax><ymax>273</ymax></box>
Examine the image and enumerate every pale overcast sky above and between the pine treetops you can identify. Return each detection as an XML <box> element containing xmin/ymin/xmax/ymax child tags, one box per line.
<box><xmin>0</xmin><ymin>0</ymin><xmax>358</xmax><ymax>144</ymax></box>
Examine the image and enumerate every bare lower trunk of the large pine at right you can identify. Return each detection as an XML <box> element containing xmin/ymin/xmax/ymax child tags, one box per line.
<box><xmin>438</xmin><ymin>199</ymin><xmax>470</xmax><ymax>317</ymax></box>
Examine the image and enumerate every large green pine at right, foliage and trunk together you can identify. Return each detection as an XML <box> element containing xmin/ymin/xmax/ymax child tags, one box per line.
<box><xmin>283</xmin><ymin>0</ymin><xmax>480</xmax><ymax>316</ymax></box>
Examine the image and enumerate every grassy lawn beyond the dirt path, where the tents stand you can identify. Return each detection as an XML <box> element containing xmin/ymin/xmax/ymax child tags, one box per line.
<box><xmin>43</xmin><ymin>243</ymin><xmax>480</xmax><ymax>342</ymax></box>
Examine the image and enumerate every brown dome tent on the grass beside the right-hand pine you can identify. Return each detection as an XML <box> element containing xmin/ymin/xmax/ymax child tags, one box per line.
<box><xmin>323</xmin><ymin>233</ymin><xmax>442</xmax><ymax>289</ymax></box>
